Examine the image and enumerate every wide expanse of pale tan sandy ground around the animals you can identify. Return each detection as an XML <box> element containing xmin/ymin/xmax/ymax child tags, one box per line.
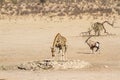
<box><xmin>0</xmin><ymin>17</ymin><xmax>120</xmax><ymax>80</ymax></box>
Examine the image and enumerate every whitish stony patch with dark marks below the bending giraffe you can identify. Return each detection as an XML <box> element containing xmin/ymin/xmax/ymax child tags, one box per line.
<box><xmin>18</xmin><ymin>60</ymin><xmax>91</xmax><ymax>70</ymax></box>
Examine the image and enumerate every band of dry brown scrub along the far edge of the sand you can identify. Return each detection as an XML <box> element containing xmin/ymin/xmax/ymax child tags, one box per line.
<box><xmin>0</xmin><ymin>0</ymin><xmax>120</xmax><ymax>18</ymax></box>
